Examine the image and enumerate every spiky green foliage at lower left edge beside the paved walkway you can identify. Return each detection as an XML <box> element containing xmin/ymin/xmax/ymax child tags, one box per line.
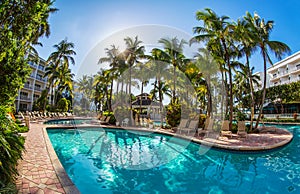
<box><xmin>0</xmin><ymin>106</ymin><xmax>25</xmax><ymax>190</ymax></box>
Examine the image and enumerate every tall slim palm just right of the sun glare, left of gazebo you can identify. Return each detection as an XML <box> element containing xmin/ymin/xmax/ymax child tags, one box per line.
<box><xmin>124</xmin><ymin>36</ymin><xmax>145</xmax><ymax>123</ymax></box>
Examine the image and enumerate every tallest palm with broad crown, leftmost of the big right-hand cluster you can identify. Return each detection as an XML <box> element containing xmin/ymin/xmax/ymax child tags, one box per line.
<box><xmin>190</xmin><ymin>8</ymin><xmax>234</xmax><ymax>129</ymax></box>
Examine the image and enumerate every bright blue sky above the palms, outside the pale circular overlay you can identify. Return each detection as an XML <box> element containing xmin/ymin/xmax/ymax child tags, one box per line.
<box><xmin>37</xmin><ymin>0</ymin><xmax>300</xmax><ymax>78</ymax></box>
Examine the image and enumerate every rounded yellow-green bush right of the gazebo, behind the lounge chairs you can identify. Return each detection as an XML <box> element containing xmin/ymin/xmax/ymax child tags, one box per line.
<box><xmin>166</xmin><ymin>100</ymin><xmax>181</xmax><ymax>127</ymax></box>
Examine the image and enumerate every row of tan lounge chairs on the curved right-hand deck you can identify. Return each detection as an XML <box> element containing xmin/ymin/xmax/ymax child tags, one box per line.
<box><xmin>176</xmin><ymin>118</ymin><xmax>247</xmax><ymax>138</ymax></box>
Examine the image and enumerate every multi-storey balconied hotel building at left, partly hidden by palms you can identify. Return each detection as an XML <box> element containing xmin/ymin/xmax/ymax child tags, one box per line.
<box><xmin>15</xmin><ymin>55</ymin><xmax>50</xmax><ymax>112</ymax></box>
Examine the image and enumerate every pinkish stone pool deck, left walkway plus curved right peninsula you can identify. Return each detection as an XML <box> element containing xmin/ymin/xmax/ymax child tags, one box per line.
<box><xmin>16</xmin><ymin>122</ymin><xmax>293</xmax><ymax>194</ymax></box>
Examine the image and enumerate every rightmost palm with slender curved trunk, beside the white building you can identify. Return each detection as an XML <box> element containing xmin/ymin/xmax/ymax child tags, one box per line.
<box><xmin>244</xmin><ymin>13</ymin><xmax>291</xmax><ymax>128</ymax></box>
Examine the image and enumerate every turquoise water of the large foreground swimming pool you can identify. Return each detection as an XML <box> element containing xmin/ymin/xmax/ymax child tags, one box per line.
<box><xmin>48</xmin><ymin>126</ymin><xmax>300</xmax><ymax>194</ymax></box>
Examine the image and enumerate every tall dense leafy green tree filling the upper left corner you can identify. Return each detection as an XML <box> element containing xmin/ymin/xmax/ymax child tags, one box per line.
<box><xmin>0</xmin><ymin>0</ymin><xmax>55</xmax><ymax>105</ymax></box>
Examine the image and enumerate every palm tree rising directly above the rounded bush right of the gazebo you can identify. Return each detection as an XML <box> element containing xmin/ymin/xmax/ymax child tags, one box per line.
<box><xmin>158</xmin><ymin>37</ymin><xmax>187</xmax><ymax>99</ymax></box>
